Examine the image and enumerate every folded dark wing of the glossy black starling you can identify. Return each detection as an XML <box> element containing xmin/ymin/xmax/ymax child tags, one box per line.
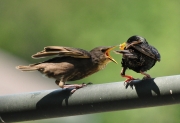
<box><xmin>128</xmin><ymin>43</ymin><xmax>161</xmax><ymax>61</ymax></box>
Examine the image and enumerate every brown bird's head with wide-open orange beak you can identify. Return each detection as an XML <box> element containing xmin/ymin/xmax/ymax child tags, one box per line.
<box><xmin>90</xmin><ymin>46</ymin><xmax>118</xmax><ymax>64</ymax></box>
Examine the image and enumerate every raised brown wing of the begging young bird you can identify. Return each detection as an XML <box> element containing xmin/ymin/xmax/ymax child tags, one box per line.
<box><xmin>32</xmin><ymin>46</ymin><xmax>91</xmax><ymax>58</ymax></box>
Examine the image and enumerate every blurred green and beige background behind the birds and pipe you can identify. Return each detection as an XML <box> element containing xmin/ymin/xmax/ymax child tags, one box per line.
<box><xmin>0</xmin><ymin>0</ymin><xmax>180</xmax><ymax>123</ymax></box>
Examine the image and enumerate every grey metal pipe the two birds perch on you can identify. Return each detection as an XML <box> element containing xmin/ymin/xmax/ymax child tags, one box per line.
<box><xmin>0</xmin><ymin>75</ymin><xmax>180</xmax><ymax>122</ymax></box>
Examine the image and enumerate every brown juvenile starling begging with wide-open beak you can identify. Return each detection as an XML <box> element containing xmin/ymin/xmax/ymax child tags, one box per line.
<box><xmin>16</xmin><ymin>46</ymin><xmax>117</xmax><ymax>92</ymax></box>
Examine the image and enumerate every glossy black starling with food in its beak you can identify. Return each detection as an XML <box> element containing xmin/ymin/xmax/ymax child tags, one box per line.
<box><xmin>115</xmin><ymin>35</ymin><xmax>160</xmax><ymax>82</ymax></box>
